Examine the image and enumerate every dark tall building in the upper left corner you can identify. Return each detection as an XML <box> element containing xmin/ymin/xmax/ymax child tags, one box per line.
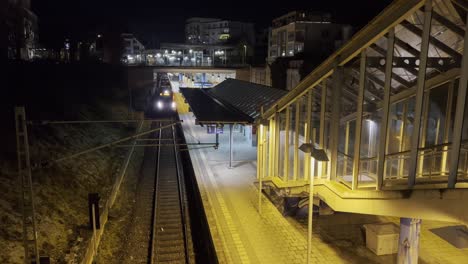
<box><xmin>0</xmin><ymin>0</ymin><xmax>38</xmax><ymax>60</ymax></box>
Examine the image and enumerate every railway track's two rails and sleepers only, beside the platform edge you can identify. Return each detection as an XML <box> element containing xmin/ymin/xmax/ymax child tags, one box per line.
<box><xmin>151</xmin><ymin>120</ymin><xmax>190</xmax><ymax>263</ymax></box>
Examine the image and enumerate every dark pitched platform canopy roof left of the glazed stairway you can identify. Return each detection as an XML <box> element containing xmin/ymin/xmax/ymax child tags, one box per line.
<box><xmin>180</xmin><ymin>79</ymin><xmax>287</xmax><ymax>124</ymax></box>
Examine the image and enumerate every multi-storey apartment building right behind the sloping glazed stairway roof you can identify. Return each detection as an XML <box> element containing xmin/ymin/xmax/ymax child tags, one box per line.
<box><xmin>265</xmin><ymin>11</ymin><xmax>352</xmax><ymax>90</ymax></box>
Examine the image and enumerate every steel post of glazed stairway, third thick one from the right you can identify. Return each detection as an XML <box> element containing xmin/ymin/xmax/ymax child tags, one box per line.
<box><xmin>376</xmin><ymin>28</ymin><xmax>395</xmax><ymax>190</ymax></box>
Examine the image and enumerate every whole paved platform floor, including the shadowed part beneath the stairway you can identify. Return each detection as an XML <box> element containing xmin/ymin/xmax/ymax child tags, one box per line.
<box><xmin>180</xmin><ymin>113</ymin><xmax>468</xmax><ymax>264</ymax></box>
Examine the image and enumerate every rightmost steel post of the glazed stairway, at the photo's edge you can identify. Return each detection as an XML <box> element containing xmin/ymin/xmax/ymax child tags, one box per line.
<box><xmin>447</xmin><ymin>12</ymin><xmax>468</xmax><ymax>188</ymax></box>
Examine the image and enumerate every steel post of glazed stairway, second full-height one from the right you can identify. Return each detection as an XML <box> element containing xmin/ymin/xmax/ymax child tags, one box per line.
<box><xmin>408</xmin><ymin>0</ymin><xmax>432</xmax><ymax>189</ymax></box>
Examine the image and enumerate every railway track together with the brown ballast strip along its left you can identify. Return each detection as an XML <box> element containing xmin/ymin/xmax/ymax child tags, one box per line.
<box><xmin>121</xmin><ymin>122</ymin><xmax>195</xmax><ymax>264</ymax></box>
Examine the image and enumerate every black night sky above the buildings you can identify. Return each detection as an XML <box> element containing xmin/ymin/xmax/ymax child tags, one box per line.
<box><xmin>32</xmin><ymin>0</ymin><xmax>391</xmax><ymax>46</ymax></box>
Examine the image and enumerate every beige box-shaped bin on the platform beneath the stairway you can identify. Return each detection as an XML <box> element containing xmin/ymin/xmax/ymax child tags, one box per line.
<box><xmin>363</xmin><ymin>223</ymin><xmax>400</xmax><ymax>256</ymax></box>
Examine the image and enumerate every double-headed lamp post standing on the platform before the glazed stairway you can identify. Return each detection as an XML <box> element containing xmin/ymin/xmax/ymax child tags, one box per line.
<box><xmin>299</xmin><ymin>143</ymin><xmax>328</xmax><ymax>263</ymax></box>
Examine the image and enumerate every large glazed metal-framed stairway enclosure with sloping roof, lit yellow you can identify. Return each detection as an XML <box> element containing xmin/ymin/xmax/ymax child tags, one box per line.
<box><xmin>258</xmin><ymin>0</ymin><xmax>468</xmax><ymax>190</ymax></box>
